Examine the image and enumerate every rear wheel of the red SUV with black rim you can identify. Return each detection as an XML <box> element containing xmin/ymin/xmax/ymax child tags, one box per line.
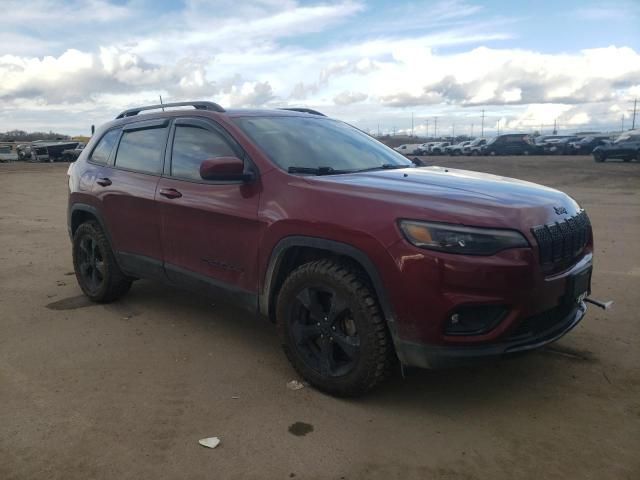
<box><xmin>73</xmin><ymin>221</ymin><xmax>131</xmax><ymax>303</ymax></box>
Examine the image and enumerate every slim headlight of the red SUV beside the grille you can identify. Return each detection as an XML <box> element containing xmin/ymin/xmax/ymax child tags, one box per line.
<box><xmin>400</xmin><ymin>220</ymin><xmax>529</xmax><ymax>255</ymax></box>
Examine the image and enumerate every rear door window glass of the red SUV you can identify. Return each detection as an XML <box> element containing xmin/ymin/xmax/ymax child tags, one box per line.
<box><xmin>115</xmin><ymin>128</ymin><xmax>167</xmax><ymax>173</ymax></box>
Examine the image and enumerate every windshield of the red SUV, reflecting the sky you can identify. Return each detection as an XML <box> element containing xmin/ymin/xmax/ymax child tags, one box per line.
<box><xmin>235</xmin><ymin>116</ymin><xmax>413</xmax><ymax>171</ymax></box>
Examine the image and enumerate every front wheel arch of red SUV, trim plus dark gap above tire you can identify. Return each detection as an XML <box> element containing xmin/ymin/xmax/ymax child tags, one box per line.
<box><xmin>259</xmin><ymin>236</ymin><xmax>396</xmax><ymax>332</ymax></box>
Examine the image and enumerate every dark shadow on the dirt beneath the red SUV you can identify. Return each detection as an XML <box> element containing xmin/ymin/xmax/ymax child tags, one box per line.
<box><xmin>108</xmin><ymin>281</ymin><xmax>597</xmax><ymax>410</ymax></box>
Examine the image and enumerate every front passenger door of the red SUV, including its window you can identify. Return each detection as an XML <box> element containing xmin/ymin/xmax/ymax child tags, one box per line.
<box><xmin>156</xmin><ymin>118</ymin><xmax>260</xmax><ymax>294</ymax></box>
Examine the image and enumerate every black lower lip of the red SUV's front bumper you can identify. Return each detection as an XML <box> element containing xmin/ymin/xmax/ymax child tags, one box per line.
<box><xmin>396</xmin><ymin>302</ymin><xmax>587</xmax><ymax>368</ymax></box>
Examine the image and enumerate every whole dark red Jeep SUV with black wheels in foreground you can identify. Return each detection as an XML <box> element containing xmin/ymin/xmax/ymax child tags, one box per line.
<box><xmin>68</xmin><ymin>102</ymin><xmax>593</xmax><ymax>395</ymax></box>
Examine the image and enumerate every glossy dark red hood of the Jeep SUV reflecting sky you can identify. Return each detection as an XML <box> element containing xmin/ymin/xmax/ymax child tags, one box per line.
<box><xmin>308</xmin><ymin>167</ymin><xmax>580</xmax><ymax>231</ymax></box>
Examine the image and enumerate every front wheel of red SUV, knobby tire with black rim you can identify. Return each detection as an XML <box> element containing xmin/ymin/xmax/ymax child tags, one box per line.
<box><xmin>276</xmin><ymin>260</ymin><xmax>396</xmax><ymax>397</ymax></box>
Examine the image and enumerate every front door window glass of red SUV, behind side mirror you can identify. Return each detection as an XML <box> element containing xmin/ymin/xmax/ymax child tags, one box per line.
<box><xmin>171</xmin><ymin>125</ymin><xmax>236</xmax><ymax>180</ymax></box>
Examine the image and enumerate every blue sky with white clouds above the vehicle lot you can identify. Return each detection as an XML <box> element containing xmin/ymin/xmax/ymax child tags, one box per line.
<box><xmin>0</xmin><ymin>0</ymin><xmax>640</xmax><ymax>135</ymax></box>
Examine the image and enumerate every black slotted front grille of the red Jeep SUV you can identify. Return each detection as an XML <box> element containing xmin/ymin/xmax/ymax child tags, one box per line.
<box><xmin>531</xmin><ymin>210</ymin><xmax>591</xmax><ymax>271</ymax></box>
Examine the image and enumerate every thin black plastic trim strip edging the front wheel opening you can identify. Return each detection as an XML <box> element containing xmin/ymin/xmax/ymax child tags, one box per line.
<box><xmin>259</xmin><ymin>236</ymin><xmax>397</xmax><ymax>338</ymax></box>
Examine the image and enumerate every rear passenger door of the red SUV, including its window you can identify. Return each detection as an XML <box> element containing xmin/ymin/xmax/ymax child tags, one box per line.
<box><xmin>95</xmin><ymin>119</ymin><xmax>169</xmax><ymax>277</ymax></box>
